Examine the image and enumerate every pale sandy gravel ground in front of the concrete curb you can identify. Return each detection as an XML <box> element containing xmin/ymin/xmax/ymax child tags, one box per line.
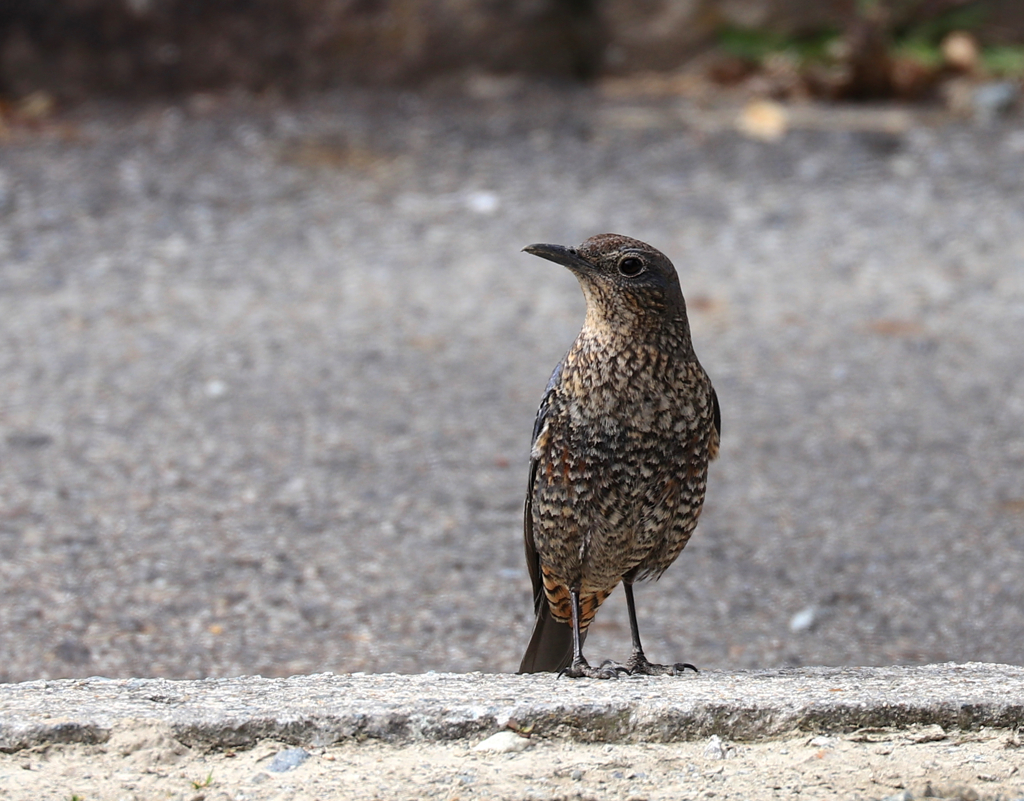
<box><xmin>0</xmin><ymin>726</ymin><xmax>1024</xmax><ymax>801</ymax></box>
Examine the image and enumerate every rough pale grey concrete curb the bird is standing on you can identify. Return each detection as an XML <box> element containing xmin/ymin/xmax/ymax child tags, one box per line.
<box><xmin>0</xmin><ymin>663</ymin><xmax>1024</xmax><ymax>752</ymax></box>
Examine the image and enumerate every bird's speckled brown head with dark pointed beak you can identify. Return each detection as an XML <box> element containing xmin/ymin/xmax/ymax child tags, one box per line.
<box><xmin>523</xmin><ymin>234</ymin><xmax>686</xmax><ymax>342</ymax></box>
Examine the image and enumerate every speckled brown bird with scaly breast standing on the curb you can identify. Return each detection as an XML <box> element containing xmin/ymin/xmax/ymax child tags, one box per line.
<box><xmin>519</xmin><ymin>234</ymin><xmax>722</xmax><ymax>679</ymax></box>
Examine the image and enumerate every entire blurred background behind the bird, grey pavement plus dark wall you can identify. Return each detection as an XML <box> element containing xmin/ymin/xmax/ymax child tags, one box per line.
<box><xmin>0</xmin><ymin>0</ymin><xmax>1024</xmax><ymax>681</ymax></box>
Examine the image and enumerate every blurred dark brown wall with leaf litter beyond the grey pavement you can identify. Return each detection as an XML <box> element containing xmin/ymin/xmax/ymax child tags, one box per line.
<box><xmin>6</xmin><ymin>0</ymin><xmax>1024</xmax><ymax>99</ymax></box>
